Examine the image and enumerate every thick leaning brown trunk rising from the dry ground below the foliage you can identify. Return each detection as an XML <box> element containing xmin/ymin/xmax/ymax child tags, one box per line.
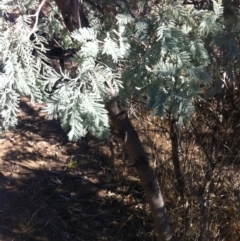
<box><xmin>106</xmin><ymin>97</ymin><xmax>176</xmax><ymax>241</ymax></box>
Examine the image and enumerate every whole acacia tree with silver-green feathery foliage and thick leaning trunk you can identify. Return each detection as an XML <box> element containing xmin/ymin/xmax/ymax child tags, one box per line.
<box><xmin>0</xmin><ymin>0</ymin><xmax>227</xmax><ymax>240</ymax></box>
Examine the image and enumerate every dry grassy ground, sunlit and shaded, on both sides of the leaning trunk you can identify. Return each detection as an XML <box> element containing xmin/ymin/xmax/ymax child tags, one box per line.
<box><xmin>0</xmin><ymin>94</ymin><xmax>240</xmax><ymax>241</ymax></box>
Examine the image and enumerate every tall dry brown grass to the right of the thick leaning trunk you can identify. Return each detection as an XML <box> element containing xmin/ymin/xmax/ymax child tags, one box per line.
<box><xmin>126</xmin><ymin>93</ymin><xmax>240</xmax><ymax>241</ymax></box>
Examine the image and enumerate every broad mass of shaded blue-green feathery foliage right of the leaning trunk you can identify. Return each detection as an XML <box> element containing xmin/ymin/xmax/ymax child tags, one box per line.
<box><xmin>120</xmin><ymin>1</ymin><xmax>214</xmax><ymax>123</ymax></box>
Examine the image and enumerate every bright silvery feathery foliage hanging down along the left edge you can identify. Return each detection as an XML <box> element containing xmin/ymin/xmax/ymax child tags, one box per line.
<box><xmin>0</xmin><ymin>0</ymin><xmax>50</xmax><ymax>132</ymax></box>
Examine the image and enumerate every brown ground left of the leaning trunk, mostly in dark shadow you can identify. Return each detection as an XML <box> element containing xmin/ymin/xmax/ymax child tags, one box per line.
<box><xmin>0</xmin><ymin>101</ymin><xmax>156</xmax><ymax>241</ymax></box>
